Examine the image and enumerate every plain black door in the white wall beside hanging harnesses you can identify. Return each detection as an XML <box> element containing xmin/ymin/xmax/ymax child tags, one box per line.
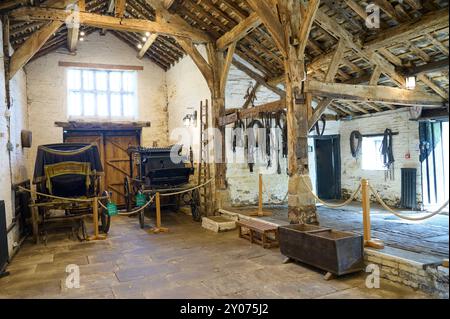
<box><xmin>315</xmin><ymin>135</ymin><xmax>341</xmax><ymax>199</ymax></box>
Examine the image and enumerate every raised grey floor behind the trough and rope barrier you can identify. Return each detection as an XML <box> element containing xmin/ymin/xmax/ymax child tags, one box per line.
<box><xmin>227</xmin><ymin>203</ymin><xmax>449</xmax><ymax>258</ymax></box>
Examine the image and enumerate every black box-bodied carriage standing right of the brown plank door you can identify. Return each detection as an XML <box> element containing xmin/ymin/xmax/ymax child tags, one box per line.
<box><xmin>124</xmin><ymin>145</ymin><xmax>201</xmax><ymax>228</ymax></box>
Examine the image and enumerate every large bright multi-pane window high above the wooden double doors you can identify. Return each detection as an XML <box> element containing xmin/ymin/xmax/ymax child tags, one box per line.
<box><xmin>67</xmin><ymin>68</ymin><xmax>137</xmax><ymax>119</ymax></box>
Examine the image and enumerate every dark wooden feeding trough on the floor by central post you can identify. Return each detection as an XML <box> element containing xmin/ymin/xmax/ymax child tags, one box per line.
<box><xmin>278</xmin><ymin>225</ymin><xmax>364</xmax><ymax>279</ymax></box>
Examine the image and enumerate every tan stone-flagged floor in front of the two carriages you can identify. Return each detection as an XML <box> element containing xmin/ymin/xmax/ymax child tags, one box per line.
<box><xmin>0</xmin><ymin>213</ymin><xmax>429</xmax><ymax>299</ymax></box>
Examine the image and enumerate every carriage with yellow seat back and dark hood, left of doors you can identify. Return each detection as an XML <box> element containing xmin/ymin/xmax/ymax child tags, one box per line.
<box><xmin>31</xmin><ymin>143</ymin><xmax>111</xmax><ymax>242</ymax></box>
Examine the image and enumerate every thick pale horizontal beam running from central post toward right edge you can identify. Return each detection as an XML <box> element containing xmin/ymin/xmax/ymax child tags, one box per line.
<box><xmin>305</xmin><ymin>80</ymin><xmax>445</xmax><ymax>107</ymax></box>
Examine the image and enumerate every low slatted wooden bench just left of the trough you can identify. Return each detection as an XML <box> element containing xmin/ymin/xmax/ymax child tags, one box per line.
<box><xmin>236</xmin><ymin>220</ymin><xmax>278</xmax><ymax>248</ymax></box>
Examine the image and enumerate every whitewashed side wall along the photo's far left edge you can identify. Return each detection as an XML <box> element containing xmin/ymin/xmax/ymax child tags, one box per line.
<box><xmin>0</xmin><ymin>22</ymin><xmax>29</xmax><ymax>254</ymax></box>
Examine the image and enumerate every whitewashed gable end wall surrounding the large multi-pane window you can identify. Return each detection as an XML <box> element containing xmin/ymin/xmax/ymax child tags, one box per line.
<box><xmin>26</xmin><ymin>32</ymin><xmax>168</xmax><ymax>176</ymax></box>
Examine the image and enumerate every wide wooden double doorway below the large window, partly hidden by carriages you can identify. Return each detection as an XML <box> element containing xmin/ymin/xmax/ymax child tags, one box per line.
<box><xmin>64</xmin><ymin>129</ymin><xmax>141</xmax><ymax>206</ymax></box>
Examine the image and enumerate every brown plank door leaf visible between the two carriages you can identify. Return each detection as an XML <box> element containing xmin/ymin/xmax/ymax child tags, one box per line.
<box><xmin>104</xmin><ymin>132</ymin><xmax>139</xmax><ymax>205</ymax></box>
